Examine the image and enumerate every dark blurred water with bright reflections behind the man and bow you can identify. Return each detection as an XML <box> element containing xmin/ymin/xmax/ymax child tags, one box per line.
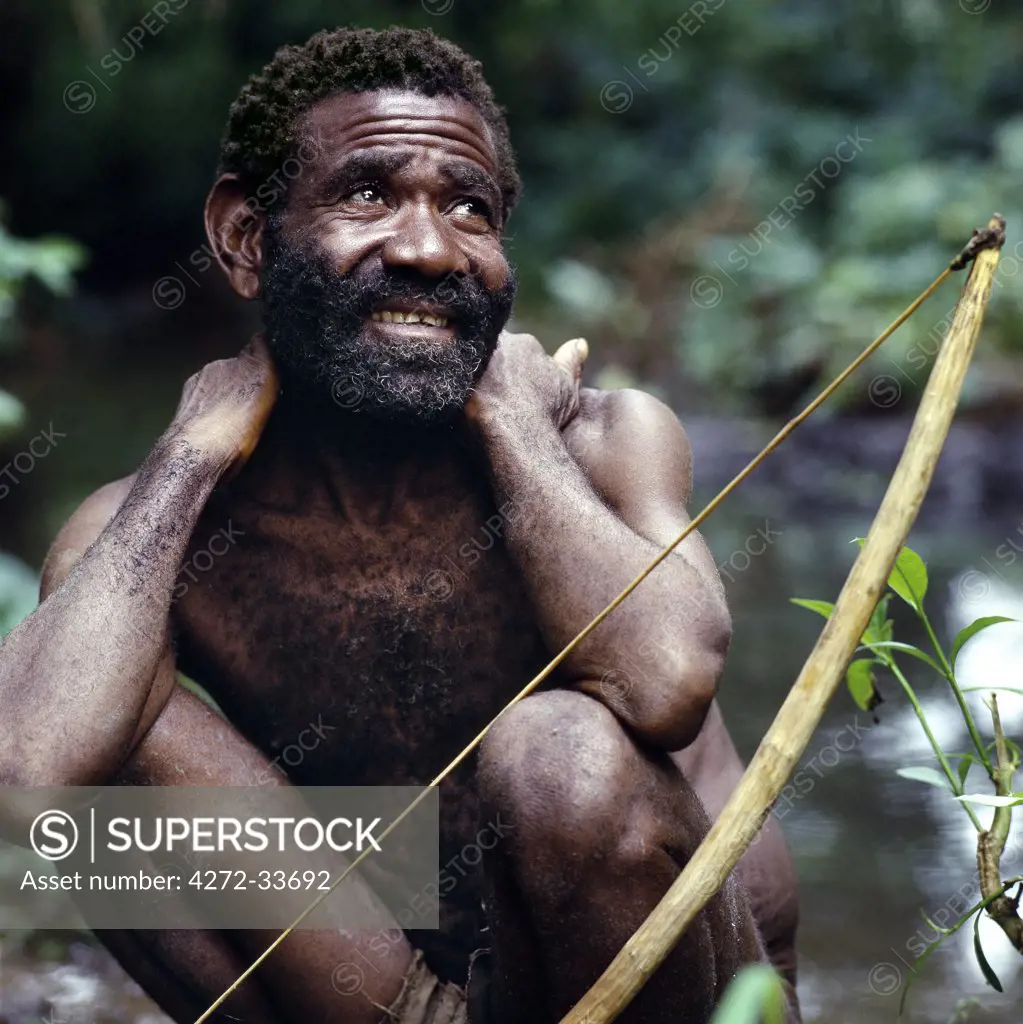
<box><xmin>0</xmin><ymin>401</ymin><xmax>1023</xmax><ymax>1024</ymax></box>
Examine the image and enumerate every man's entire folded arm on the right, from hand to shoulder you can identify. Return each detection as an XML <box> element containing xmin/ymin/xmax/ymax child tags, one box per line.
<box><xmin>467</xmin><ymin>335</ymin><xmax>731</xmax><ymax>751</ymax></box>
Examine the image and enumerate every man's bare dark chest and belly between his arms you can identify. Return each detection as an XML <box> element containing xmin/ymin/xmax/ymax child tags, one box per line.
<box><xmin>174</xmin><ymin>483</ymin><xmax>546</xmax><ymax>784</ymax></box>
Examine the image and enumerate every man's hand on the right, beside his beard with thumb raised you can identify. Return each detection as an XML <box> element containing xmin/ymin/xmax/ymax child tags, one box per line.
<box><xmin>465</xmin><ymin>331</ymin><xmax>589</xmax><ymax>430</ymax></box>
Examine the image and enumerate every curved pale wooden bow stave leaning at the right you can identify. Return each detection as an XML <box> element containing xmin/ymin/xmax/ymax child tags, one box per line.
<box><xmin>562</xmin><ymin>214</ymin><xmax>1006</xmax><ymax>1024</ymax></box>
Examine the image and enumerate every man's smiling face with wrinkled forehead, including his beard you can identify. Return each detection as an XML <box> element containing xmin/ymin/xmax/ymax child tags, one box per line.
<box><xmin>261</xmin><ymin>90</ymin><xmax>515</xmax><ymax>421</ymax></box>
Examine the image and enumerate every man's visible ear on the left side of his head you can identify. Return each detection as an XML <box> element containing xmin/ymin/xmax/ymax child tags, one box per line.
<box><xmin>205</xmin><ymin>174</ymin><xmax>266</xmax><ymax>299</ymax></box>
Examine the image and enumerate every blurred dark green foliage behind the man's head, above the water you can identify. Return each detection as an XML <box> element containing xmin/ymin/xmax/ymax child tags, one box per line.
<box><xmin>0</xmin><ymin>0</ymin><xmax>1023</xmax><ymax>413</ymax></box>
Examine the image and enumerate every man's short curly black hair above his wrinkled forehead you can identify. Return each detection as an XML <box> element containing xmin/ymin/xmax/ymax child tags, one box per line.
<box><xmin>218</xmin><ymin>26</ymin><xmax>521</xmax><ymax>217</ymax></box>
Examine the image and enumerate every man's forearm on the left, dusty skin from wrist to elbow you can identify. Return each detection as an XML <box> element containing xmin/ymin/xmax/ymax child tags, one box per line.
<box><xmin>0</xmin><ymin>440</ymin><xmax>222</xmax><ymax>785</ymax></box>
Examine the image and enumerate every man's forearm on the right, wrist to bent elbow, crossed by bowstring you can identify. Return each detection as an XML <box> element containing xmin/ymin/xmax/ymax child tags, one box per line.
<box><xmin>481</xmin><ymin>403</ymin><xmax>728</xmax><ymax>749</ymax></box>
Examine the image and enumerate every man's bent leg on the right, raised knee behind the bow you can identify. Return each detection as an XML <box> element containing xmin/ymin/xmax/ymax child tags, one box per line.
<box><xmin>479</xmin><ymin>690</ymin><xmax>764</xmax><ymax>1024</ymax></box>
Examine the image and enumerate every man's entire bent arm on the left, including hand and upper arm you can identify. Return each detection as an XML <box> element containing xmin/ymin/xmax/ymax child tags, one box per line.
<box><xmin>0</xmin><ymin>335</ymin><xmax>278</xmax><ymax>785</ymax></box>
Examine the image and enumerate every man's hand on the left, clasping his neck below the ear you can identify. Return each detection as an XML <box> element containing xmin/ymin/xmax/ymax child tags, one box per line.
<box><xmin>164</xmin><ymin>334</ymin><xmax>280</xmax><ymax>472</ymax></box>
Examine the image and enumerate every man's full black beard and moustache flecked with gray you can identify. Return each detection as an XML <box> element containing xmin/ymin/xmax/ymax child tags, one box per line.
<box><xmin>261</xmin><ymin>222</ymin><xmax>516</xmax><ymax>423</ymax></box>
